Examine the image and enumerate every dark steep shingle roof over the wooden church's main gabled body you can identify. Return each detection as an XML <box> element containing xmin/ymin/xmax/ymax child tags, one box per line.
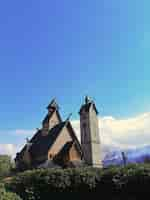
<box><xmin>16</xmin><ymin>118</ymin><xmax>82</xmax><ymax>165</ymax></box>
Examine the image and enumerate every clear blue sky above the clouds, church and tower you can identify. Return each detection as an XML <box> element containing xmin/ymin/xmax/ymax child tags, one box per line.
<box><xmin>0</xmin><ymin>0</ymin><xmax>150</xmax><ymax>153</ymax></box>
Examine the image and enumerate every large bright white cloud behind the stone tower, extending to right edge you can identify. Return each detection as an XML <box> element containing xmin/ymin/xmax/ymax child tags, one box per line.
<box><xmin>72</xmin><ymin>113</ymin><xmax>150</xmax><ymax>149</ymax></box>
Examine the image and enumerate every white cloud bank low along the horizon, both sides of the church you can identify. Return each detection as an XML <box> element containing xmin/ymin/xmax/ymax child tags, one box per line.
<box><xmin>0</xmin><ymin>113</ymin><xmax>150</xmax><ymax>158</ymax></box>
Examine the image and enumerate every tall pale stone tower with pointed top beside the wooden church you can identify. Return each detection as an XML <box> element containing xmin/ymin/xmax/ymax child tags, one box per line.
<box><xmin>79</xmin><ymin>96</ymin><xmax>102</xmax><ymax>167</ymax></box>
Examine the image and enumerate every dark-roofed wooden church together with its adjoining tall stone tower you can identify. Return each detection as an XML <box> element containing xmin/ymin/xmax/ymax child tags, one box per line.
<box><xmin>15</xmin><ymin>97</ymin><xmax>102</xmax><ymax>171</ymax></box>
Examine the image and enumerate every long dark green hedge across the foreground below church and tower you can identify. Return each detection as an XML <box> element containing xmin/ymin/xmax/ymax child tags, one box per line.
<box><xmin>6</xmin><ymin>164</ymin><xmax>150</xmax><ymax>200</ymax></box>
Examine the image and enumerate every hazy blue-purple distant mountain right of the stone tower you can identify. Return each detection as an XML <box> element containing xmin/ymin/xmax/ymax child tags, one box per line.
<box><xmin>103</xmin><ymin>146</ymin><xmax>150</xmax><ymax>166</ymax></box>
